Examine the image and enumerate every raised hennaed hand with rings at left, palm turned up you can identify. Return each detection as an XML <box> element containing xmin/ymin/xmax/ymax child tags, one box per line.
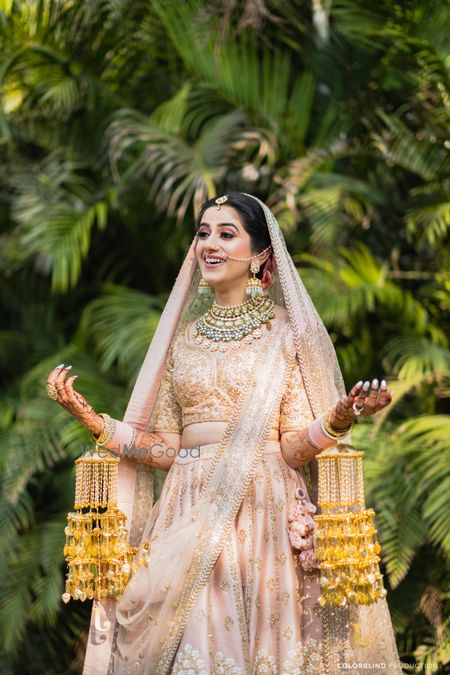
<box><xmin>47</xmin><ymin>363</ymin><xmax>103</xmax><ymax>436</ymax></box>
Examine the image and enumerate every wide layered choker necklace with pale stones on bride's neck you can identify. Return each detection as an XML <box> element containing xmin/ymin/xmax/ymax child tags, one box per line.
<box><xmin>194</xmin><ymin>296</ymin><xmax>275</xmax><ymax>352</ymax></box>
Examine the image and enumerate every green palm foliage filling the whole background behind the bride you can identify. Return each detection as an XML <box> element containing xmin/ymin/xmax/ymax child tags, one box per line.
<box><xmin>0</xmin><ymin>0</ymin><xmax>450</xmax><ymax>675</ymax></box>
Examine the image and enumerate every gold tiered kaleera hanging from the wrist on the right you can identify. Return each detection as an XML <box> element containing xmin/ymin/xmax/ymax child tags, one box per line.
<box><xmin>314</xmin><ymin>443</ymin><xmax>386</xmax><ymax>607</ymax></box>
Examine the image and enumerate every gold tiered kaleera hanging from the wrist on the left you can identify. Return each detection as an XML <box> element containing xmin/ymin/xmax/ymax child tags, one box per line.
<box><xmin>62</xmin><ymin>447</ymin><xmax>147</xmax><ymax>602</ymax></box>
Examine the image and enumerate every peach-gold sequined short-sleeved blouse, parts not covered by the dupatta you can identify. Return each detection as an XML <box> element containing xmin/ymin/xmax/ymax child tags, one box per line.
<box><xmin>151</xmin><ymin>318</ymin><xmax>313</xmax><ymax>436</ymax></box>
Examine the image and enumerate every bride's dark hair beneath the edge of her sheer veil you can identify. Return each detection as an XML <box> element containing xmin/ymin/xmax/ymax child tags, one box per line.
<box><xmin>196</xmin><ymin>192</ymin><xmax>273</xmax><ymax>285</ymax></box>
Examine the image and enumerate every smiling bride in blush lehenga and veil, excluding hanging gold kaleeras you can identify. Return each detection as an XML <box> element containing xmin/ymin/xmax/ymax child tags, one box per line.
<box><xmin>47</xmin><ymin>192</ymin><xmax>399</xmax><ymax>675</ymax></box>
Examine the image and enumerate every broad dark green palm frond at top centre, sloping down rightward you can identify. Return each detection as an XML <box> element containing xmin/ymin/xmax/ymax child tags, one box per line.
<box><xmin>151</xmin><ymin>0</ymin><xmax>315</xmax><ymax>152</ymax></box>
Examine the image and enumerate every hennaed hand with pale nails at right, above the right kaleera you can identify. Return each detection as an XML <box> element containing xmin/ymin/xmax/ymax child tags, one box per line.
<box><xmin>329</xmin><ymin>380</ymin><xmax>392</xmax><ymax>430</ymax></box>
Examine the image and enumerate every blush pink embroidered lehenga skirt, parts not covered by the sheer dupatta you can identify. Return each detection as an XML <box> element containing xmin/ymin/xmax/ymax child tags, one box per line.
<box><xmin>110</xmin><ymin>441</ymin><xmax>398</xmax><ymax>675</ymax></box>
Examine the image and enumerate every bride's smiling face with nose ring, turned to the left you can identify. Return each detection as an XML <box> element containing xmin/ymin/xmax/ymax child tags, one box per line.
<box><xmin>195</xmin><ymin>204</ymin><xmax>255</xmax><ymax>290</ymax></box>
